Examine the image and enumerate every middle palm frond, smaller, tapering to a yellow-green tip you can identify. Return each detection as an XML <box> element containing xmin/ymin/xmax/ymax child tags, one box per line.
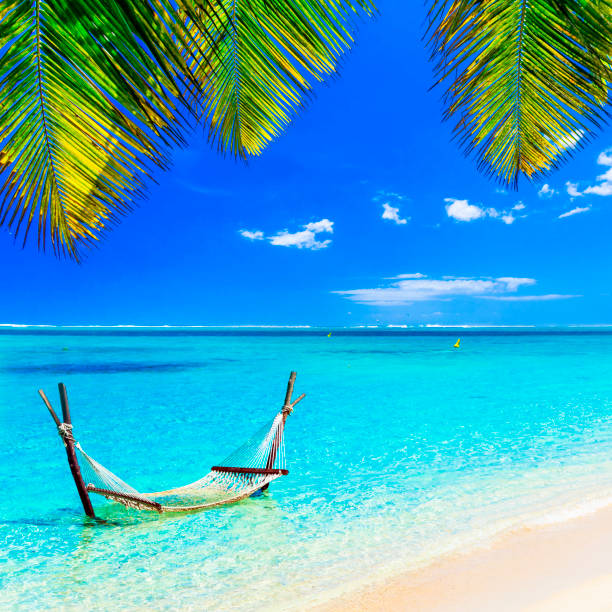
<box><xmin>179</xmin><ymin>0</ymin><xmax>375</xmax><ymax>157</ymax></box>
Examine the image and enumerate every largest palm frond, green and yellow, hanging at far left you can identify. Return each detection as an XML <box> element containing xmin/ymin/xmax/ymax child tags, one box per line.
<box><xmin>0</xmin><ymin>0</ymin><xmax>196</xmax><ymax>259</ymax></box>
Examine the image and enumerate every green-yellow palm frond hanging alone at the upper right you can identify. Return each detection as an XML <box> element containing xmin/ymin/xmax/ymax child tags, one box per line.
<box><xmin>430</xmin><ymin>0</ymin><xmax>612</xmax><ymax>185</ymax></box>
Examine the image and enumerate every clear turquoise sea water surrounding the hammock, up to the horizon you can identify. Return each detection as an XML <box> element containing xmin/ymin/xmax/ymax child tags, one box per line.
<box><xmin>0</xmin><ymin>330</ymin><xmax>612</xmax><ymax>610</ymax></box>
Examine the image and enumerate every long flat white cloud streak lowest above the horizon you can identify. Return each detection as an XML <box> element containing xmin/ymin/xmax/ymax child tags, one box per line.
<box><xmin>333</xmin><ymin>274</ymin><xmax>536</xmax><ymax>306</ymax></box>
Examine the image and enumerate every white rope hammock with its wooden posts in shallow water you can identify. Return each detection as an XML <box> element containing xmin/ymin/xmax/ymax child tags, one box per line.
<box><xmin>39</xmin><ymin>372</ymin><xmax>305</xmax><ymax>517</ymax></box>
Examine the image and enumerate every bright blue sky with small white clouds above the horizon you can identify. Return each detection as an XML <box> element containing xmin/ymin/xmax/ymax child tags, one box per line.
<box><xmin>0</xmin><ymin>2</ymin><xmax>612</xmax><ymax>326</ymax></box>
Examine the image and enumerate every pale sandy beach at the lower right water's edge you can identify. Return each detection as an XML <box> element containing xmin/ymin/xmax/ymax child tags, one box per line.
<box><xmin>319</xmin><ymin>507</ymin><xmax>612</xmax><ymax>612</ymax></box>
